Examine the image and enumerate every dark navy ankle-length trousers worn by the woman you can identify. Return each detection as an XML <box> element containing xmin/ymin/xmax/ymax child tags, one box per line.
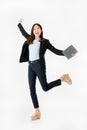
<box><xmin>28</xmin><ymin>60</ymin><xmax>61</xmax><ymax>108</ymax></box>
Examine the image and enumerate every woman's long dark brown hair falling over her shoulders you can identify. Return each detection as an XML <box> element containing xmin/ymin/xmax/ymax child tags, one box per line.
<box><xmin>28</xmin><ymin>23</ymin><xmax>44</xmax><ymax>44</ymax></box>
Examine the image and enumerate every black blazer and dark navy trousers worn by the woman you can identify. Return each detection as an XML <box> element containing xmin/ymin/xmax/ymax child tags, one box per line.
<box><xmin>18</xmin><ymin>24</ymin><xmax>63</xmax><ymax>108</ymax></box>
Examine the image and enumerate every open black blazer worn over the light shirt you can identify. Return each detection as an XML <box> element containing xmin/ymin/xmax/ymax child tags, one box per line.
<box><xmin>18</xmin><ymin>23</ymin><xmax>64</xmax><ymax>69</ymax></box>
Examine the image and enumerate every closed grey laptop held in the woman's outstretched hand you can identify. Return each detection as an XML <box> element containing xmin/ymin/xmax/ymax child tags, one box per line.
<box><xmin>63</xmin><ymin>45</ymin><xmax>77</xmax><ymax>59</ymax></box>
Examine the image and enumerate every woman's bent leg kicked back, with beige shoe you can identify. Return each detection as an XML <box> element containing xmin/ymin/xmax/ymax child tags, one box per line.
<box><xmin>34</xmin><ymin>62</ymin><xmax>72</xmax><ymax>91</ymax></box>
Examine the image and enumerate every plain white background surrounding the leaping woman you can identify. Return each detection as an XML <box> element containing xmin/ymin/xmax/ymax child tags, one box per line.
<box><xmin>0</xmin><ymin>0</ymin><xmax>87</xmax><ymax>130</ymax></box>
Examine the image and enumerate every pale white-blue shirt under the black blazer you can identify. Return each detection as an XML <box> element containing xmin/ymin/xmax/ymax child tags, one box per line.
<box><xmin>29</xmin><ymin>39</ymin><xmax>40</xmax><ymax>61</ymax></box>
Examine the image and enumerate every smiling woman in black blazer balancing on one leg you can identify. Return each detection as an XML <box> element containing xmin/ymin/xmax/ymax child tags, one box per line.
<box><xmin>18</xmin><ymin>19</ymin><xmax>72</xmax><ymax>120</ymax></box>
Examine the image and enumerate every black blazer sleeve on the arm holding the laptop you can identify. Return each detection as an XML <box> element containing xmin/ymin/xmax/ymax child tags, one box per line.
<box><xmin>47</xmin><ymin>40</ymin><xmax>64</xmax><ymax>56</ymax></box>
